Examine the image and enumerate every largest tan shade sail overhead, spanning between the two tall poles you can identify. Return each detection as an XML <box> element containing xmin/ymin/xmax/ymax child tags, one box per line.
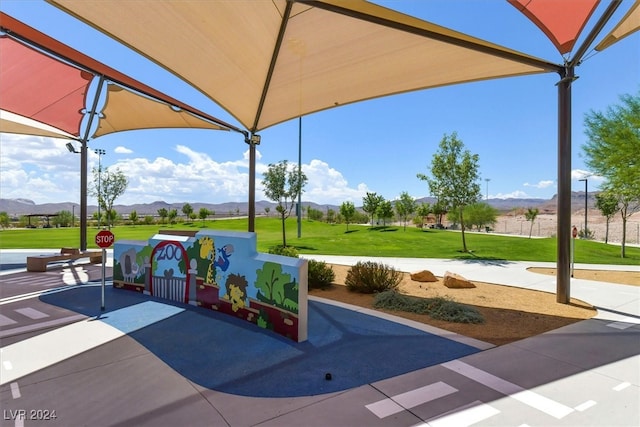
<box><xmin>48</xmin><ymin>0</ymin><xmax>560</xmax><ymax>131</ymax></box>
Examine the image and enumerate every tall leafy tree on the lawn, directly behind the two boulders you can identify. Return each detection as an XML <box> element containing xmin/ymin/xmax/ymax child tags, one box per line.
<box><xmin>417</xmin><ymin>132</ymin><xmax>481</xmax><ymax>252</ymax></box>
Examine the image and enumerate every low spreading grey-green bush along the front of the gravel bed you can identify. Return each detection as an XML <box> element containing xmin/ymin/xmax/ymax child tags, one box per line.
<box><xmin>373</xmin><ymin>291</ymin><xmax>484</xmax><ymax>323</ymax></box>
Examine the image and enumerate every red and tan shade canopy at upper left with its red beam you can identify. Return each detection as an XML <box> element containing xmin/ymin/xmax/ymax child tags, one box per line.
<box><xmin>0</xmin><ymin>13</ymin><xmax>238</xmax><ymax>137</ymax></box>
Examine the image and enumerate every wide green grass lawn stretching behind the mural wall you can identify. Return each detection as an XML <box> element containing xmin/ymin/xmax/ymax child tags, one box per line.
<box><xmin>0</xmin><ymin>218</ymin><xmax>640</xmax><ymax>265</ymax></box>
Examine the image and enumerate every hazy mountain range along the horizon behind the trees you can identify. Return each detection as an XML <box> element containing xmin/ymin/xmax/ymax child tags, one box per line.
<box><xmin>0</xmin><ymin>191</ymin><xmax>596</xmax><ymax>217</ymax></box>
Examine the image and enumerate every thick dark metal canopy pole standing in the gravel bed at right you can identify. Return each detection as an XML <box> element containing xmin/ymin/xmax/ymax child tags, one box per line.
<box><xmin>556</xmin><ymin>66</ymin><xmax>574</xmax><ymax>304</ymax></box>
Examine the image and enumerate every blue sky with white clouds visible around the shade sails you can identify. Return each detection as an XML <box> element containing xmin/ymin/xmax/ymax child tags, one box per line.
<box><xmin>0</xmin><ymin>0</ymin><xmax>640</xmax><ymax>205</ymax></box>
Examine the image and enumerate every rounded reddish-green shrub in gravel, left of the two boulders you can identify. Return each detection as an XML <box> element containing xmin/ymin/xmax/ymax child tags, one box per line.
<box><xmin>345</xmin><ymin>261</ymin><xmax>402</xmax><ymax>294</ymax></box>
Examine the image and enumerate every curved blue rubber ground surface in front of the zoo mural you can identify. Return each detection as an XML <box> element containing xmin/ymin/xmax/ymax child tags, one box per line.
<box><xmin>41</xmin><ymin>287</ymin><xmax>480</xmax><ymax>397</ymax></box>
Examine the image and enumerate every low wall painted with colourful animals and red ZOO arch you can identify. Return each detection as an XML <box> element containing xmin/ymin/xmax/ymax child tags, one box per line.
<box><xmin>113</xmin><ymin>230</ymin><xmax>307</xmax><ymax>342</ymax></box>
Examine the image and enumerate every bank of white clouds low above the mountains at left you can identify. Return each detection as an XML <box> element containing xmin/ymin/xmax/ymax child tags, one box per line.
<box><xmin>0</xmin><ymin>134</ymin><xmax>371</xmax><ymax>205</ymax></box>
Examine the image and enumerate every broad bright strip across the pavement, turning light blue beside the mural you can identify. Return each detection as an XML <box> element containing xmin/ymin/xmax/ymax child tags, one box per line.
<box><xmin>0</xmin><ymin>301</ymin><xmax>184</xmax><ymax>385</ymax></box>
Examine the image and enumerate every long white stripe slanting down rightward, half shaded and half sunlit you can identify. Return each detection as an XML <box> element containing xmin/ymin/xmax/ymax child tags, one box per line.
<box><xmin>441</xmin><ymin>360</ymin><xmax>573</xmax><ymax>419</ymax></box>
